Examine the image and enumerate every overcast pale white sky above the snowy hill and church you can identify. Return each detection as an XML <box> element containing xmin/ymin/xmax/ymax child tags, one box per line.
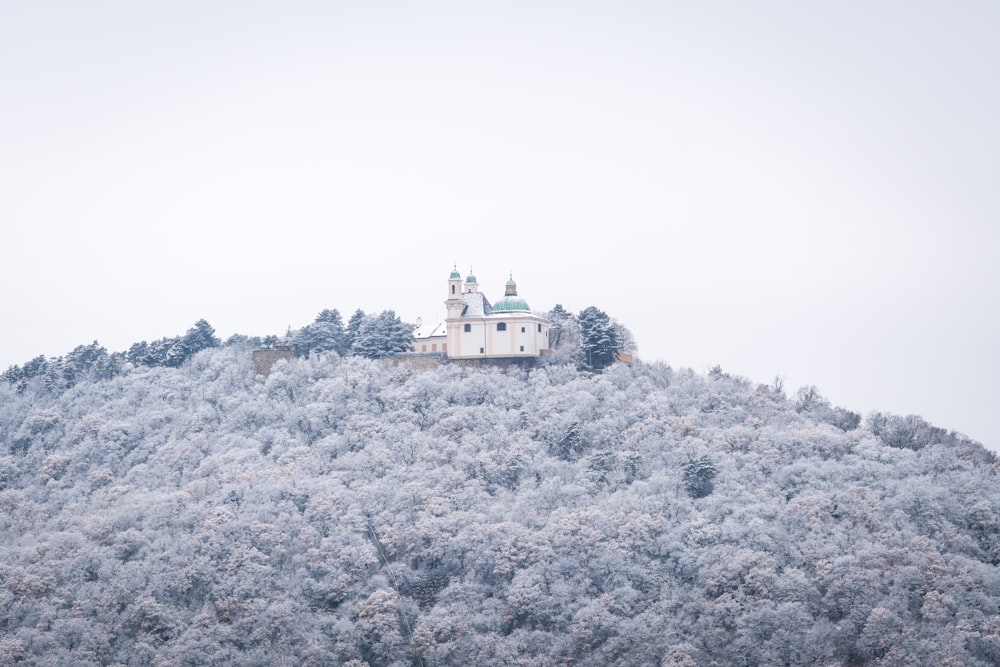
<box><xmin>0</xmin><ymin>0</ymin><xmax>1000</xmax><ymax>450</ymax></box>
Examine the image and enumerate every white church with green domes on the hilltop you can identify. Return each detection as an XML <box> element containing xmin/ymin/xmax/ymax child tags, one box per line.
<box><xmin>413</xmin><ymin>269</ymin><xmax>549</xmax><ymax>359</ymax></box>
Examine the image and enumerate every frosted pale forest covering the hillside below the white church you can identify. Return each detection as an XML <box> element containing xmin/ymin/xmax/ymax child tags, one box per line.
<box><xmin>0</xmin><ymin>332</ymin><xmax>1000</xmax><ymax>667</ymax></box>
